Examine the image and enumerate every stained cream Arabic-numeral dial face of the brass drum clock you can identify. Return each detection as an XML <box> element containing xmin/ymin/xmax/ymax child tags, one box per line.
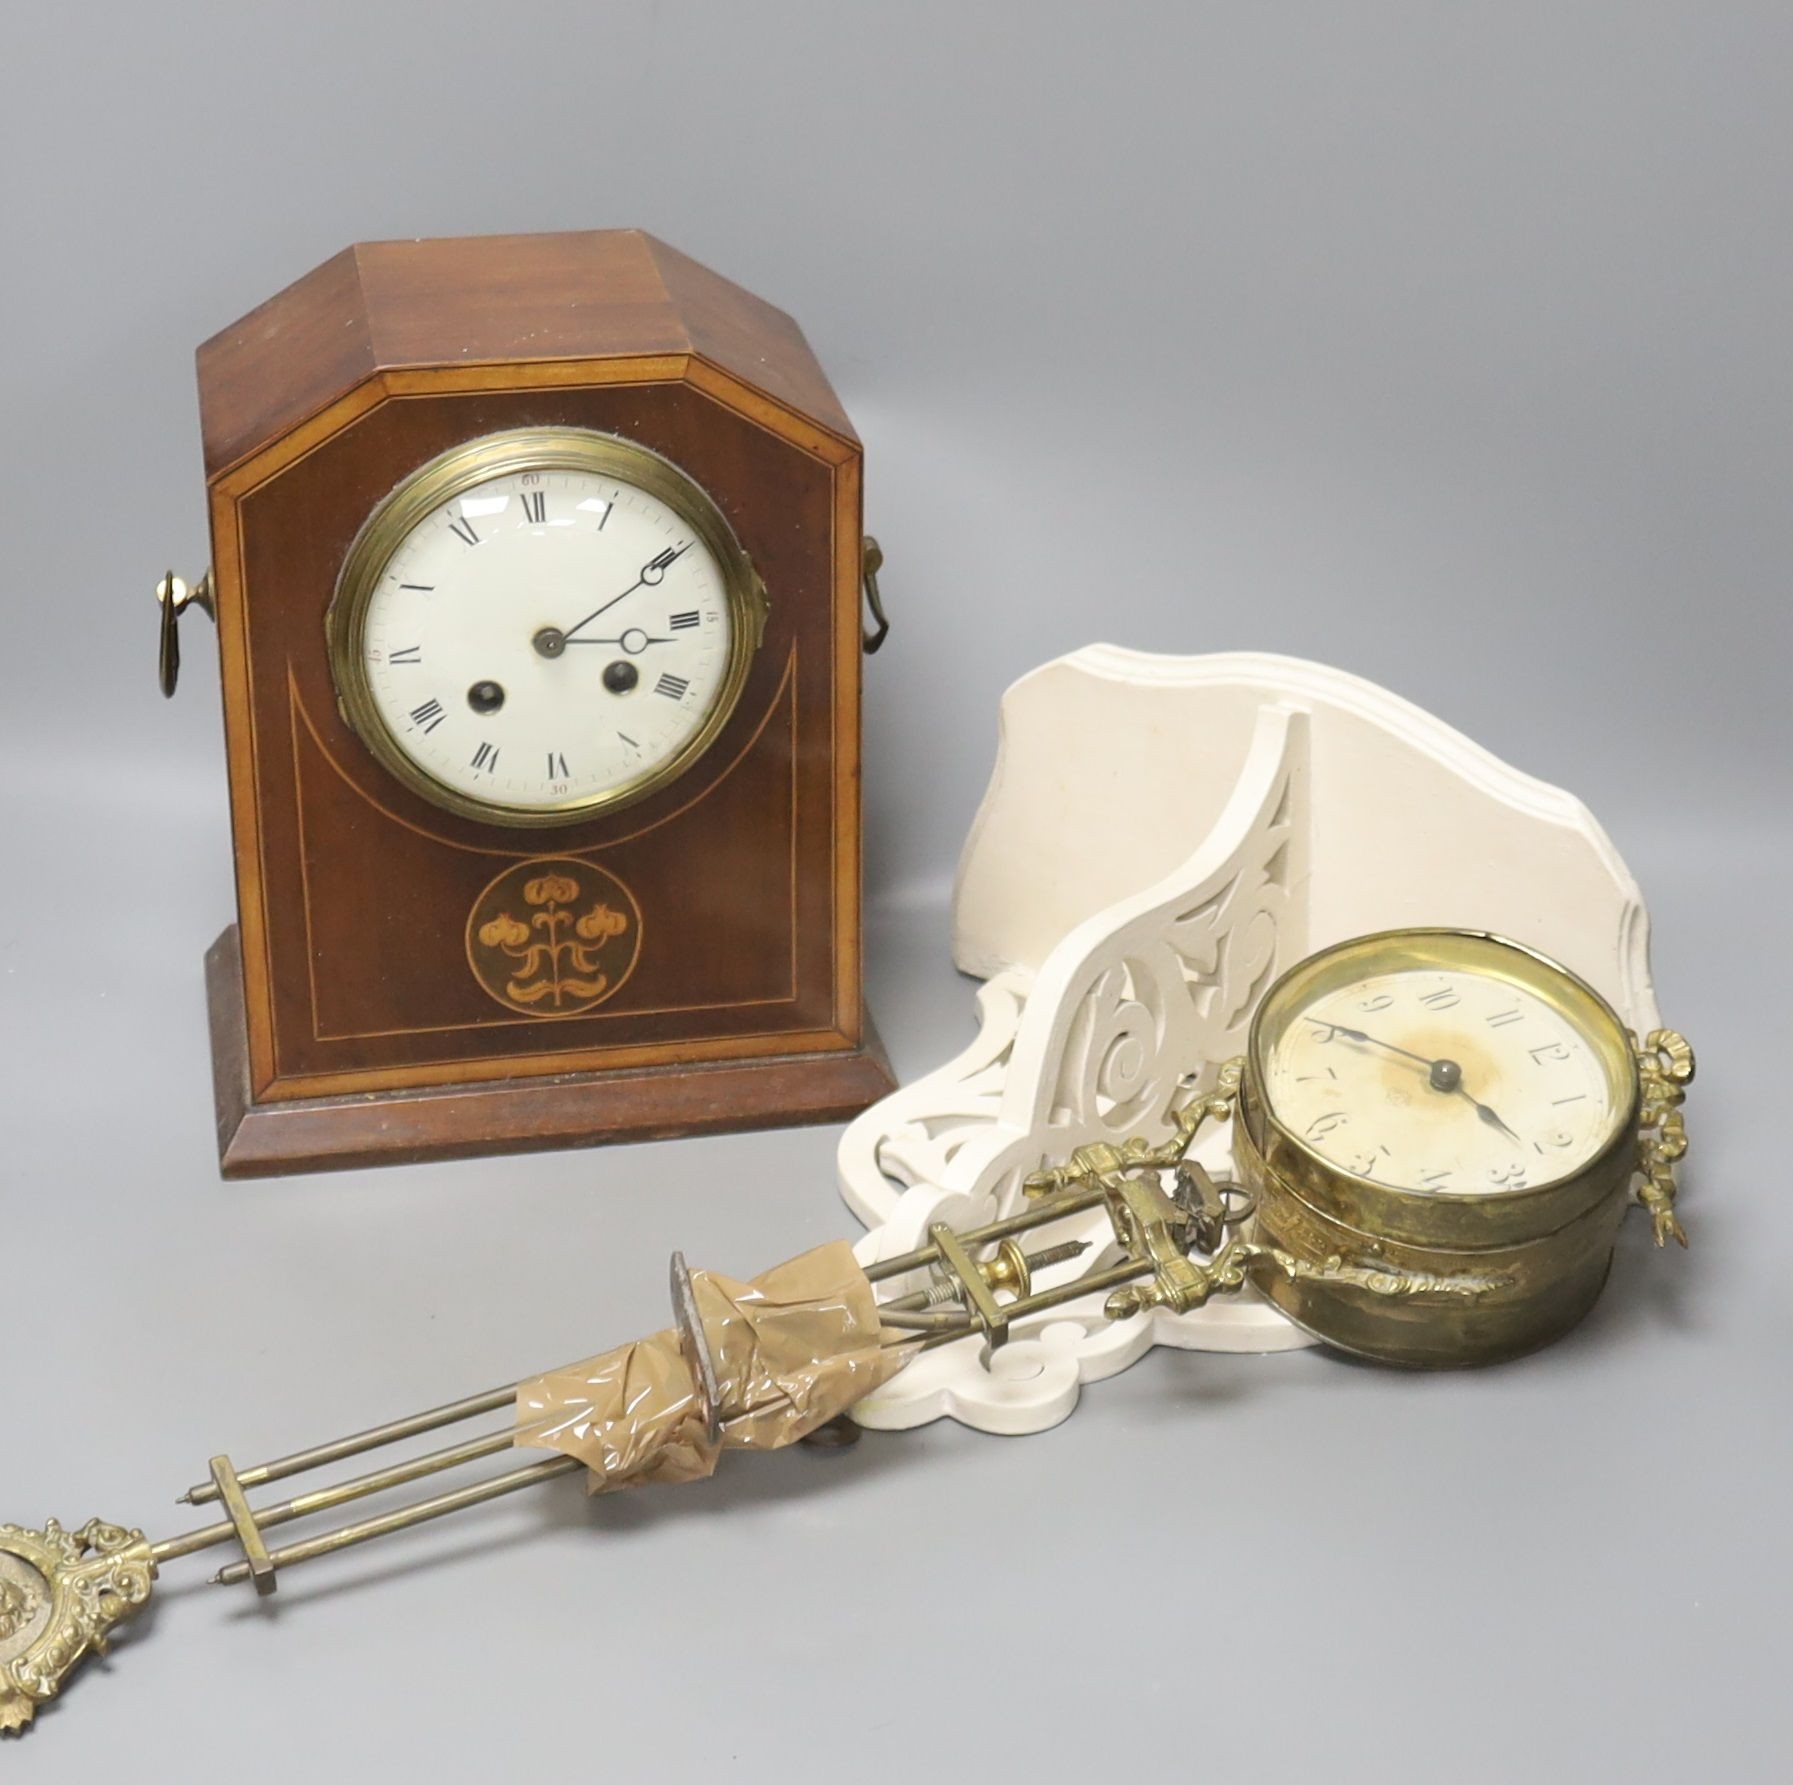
<box><xmin>1266</xmin><ymin>968</ymin><xmax>1614</xmax><ymax>1195</ymax></box>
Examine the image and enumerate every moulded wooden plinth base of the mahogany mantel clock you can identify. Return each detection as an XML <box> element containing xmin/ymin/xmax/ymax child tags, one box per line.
<box><xmin>206</xmin><ymin>925</ymin><xmax>897</xmax><ymax>1177</ymax></box>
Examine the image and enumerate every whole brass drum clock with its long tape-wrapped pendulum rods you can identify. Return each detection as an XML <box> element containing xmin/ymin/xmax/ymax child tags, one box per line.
<box><xmin>0</xmin><ymin>930</ymin><xmax>1694</xmax><ymax>1731</ymax></box>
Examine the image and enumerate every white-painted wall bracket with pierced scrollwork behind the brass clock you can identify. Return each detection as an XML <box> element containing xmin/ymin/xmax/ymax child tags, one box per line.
<box><xmin>839</xmin><ymin>645</ymin><xmax>1659</xmax><ymax>1432</ymax></box>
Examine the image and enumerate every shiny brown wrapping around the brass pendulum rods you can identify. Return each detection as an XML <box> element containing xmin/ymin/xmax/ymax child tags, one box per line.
<box><xmin>516</xmin><ymin>1240</ymin><xmax>914</xmax><ymax>1493</ymax></box>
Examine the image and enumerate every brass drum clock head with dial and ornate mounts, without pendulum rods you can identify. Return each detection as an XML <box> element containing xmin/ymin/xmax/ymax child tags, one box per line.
<box><xmin>1036</xmin><ymin>930</ymin><xmax>1694</xmax><ymax>1367</ymax></box>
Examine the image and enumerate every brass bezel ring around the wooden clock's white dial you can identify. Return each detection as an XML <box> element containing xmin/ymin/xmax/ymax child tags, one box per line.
<box><xmin>325</xmin><ymin>428</ymin><xmax>767</xmax><ymax>830</ymax></box>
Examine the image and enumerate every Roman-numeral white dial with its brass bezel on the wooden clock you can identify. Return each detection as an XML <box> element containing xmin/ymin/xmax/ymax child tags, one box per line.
<box><xmin>330</xmin><ymin>428</ymin><xmax>764</xmax><ymax>824</ymax></box>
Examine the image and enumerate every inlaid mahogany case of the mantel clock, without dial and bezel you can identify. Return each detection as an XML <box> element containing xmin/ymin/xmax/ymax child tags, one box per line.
<box><xmin>199</xmin><ymin>231</ymin><xmax>891</xmax><ymax>1176</ymax></box>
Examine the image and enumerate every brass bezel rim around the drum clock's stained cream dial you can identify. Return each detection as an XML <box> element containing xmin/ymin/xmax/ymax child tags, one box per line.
<box><xmin>1241</xmin><ymin>928</ymin><xmax>1639</xmax><ymax>1247</ymax></box>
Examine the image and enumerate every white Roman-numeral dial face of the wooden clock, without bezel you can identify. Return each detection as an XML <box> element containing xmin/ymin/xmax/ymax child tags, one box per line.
<box><xmin>360</xmin><ymin>470</ymin><xmax>733</xmax><ymax>812</ymax></box>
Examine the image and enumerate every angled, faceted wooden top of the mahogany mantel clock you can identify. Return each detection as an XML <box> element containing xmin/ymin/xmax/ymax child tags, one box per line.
<box><xmin>199</xmin><ymin>229</ymin><xmax>857</xmax><ymax>479</ymax></box>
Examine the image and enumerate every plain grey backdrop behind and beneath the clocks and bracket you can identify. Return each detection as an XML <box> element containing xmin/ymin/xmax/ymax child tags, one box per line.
<box><xmin>0</xmin><ymin>0</ymin><xmax>1793</xmax><ymax>1781</ymax></box>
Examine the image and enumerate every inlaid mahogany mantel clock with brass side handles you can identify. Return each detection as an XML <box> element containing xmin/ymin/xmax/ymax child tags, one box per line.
<box><xmin>158</xmin><ymin>231</ymin><xmax>891</xmax><ymax>1176</ymax></box>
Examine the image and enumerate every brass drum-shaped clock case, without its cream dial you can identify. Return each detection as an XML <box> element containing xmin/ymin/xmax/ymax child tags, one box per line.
<box><xmin>1234</xmin><ymin>930</ymin><xmax>1693</xmax><ymax>1367</ymax></box>
